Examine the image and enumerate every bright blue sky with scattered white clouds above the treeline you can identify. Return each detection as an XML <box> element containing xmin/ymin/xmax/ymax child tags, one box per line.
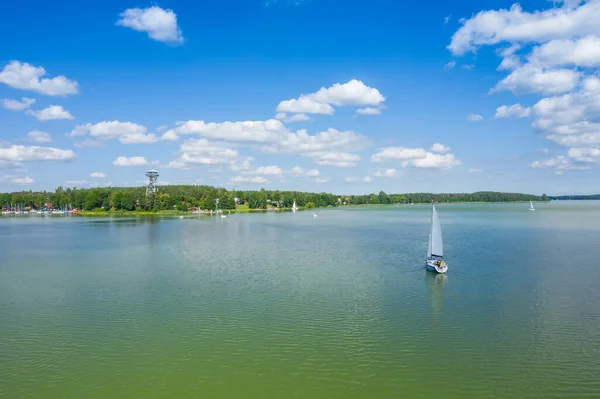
<box><xmin>0</xmin><ymin>0</ymin><xmax>600</xmax><ymax>195</ymax></box>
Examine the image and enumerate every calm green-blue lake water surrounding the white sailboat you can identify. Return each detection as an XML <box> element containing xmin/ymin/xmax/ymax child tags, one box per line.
<box><xmin>0</xmin><ymin>202</ymin><xmax>600</xmax><ymax>399</ymax></box>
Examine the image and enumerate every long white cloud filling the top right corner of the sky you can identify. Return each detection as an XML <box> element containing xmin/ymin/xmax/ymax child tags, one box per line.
<box><xmin>448</xmin><ymin>0</ymin><xmax>600</xmax><ymax>55</ymax></box>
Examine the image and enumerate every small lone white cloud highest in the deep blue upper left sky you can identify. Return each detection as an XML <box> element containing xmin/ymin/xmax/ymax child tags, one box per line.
<box><xmin>117</xmin><ymin>6</ymin><xmax>183</xmax><ymax>44</ymax></box>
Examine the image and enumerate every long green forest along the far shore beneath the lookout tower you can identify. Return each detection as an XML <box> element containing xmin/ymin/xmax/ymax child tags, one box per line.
<box><xmin>0</xmin><ymin>185</ymin><xmax>548</xmax><ymax>211</ymax></box>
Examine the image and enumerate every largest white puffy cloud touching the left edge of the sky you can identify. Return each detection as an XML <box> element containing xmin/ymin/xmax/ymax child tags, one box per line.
<box><xmin>0</xmin><ymin>61</ymin><xmax>79</xmax><ymax>96</ymax></box>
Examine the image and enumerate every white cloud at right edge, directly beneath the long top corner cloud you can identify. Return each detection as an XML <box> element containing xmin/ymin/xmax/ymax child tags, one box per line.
<box><xmin>528</xmin><ymin>36</ymin><xmax>600</xmax><ymax>68</ymax></box>
